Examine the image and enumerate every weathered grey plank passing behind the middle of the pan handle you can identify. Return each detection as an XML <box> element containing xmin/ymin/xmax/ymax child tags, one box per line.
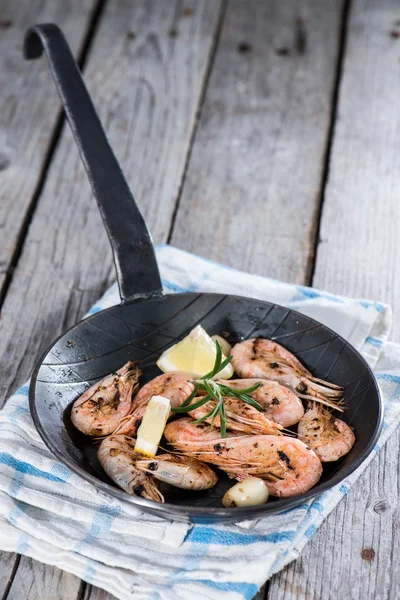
<box><xmin>0</xmin><ymin>0</ymin><xmax>219</xmax><ymax>398</ymax></box>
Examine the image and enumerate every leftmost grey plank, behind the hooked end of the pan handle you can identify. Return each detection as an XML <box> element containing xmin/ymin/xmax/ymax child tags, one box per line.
<box><xmin>0</xmin><ymin>0</ymin><xmax>96</xmax><ymax>290</ymax></box>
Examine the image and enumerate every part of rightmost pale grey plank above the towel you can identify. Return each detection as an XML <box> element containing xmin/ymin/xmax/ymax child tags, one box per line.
<box><xmin>313</xmin><ymin>0</ymin><xmax>400</xmax><ymax>340</ymax></box>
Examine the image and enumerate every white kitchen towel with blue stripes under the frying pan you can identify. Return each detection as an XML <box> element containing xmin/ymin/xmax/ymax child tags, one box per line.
<box><xmin>0</xmin><ymin>245</ymin><xmax>400</xmax><ymax>600</ymax></box>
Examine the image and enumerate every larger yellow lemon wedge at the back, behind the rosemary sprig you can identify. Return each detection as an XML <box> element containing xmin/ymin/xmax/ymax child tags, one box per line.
<box><xmin>157</xmin><ymin>325</ymin><xmax>233</xmax><ymax>379</ymax></box>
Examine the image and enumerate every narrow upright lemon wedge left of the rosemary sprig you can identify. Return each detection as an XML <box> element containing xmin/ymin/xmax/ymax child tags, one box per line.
<box><xmin>135</xmin><ymin>396</ymin><xmax>171</xmax><ymax>458</ymax></box>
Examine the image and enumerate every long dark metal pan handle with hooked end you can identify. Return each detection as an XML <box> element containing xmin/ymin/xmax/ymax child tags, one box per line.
<box><xmin>24</xmin><ymin>23</ymin><xmax>162</xmax><ymax>304</ymax></box>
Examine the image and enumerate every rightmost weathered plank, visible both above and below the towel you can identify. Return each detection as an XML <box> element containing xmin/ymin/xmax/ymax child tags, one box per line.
<box><xmin>269</xmin><ymin>0</ymin><xmax>400</xmax><ymax>600</ymax></box>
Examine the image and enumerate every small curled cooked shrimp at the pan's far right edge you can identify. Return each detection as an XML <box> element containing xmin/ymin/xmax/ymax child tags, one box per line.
<box><xmin>297</xmin><ymin>402</ymin><xmax>356</xmax><ymax>462</ymax></box>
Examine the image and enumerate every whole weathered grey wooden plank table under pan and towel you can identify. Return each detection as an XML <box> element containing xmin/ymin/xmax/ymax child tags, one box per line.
<box><xmin>0</xmin><ymin>0</ymin><xmax>400</xmax><ymax>600</ymax></box>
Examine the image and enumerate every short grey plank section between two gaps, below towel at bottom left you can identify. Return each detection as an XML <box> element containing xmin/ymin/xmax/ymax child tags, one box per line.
<box><xmin>7</xmin><ymin>556</ymin><xmax>83</xmax><ymax>600</ymax></box>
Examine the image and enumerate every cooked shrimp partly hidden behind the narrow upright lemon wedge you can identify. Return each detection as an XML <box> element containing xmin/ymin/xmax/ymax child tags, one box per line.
<box><xmin>113</xmin><ymin>373</ymin><xmax>194</xmax><ymax>436</ymax></box>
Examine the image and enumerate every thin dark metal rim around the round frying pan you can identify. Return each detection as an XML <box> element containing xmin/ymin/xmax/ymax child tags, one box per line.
<box><xmin>29</xmin><ymin>292</ymin><xmax>384</xmax><ymax>522</ymax></box>
